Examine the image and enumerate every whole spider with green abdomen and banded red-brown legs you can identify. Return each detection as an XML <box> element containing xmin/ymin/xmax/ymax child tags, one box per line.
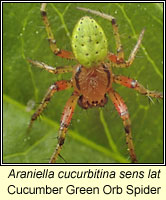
<box><xmin>28</xmin><ymin>3</ymin><xmax>163</xmax><ymax>163</ymax></box>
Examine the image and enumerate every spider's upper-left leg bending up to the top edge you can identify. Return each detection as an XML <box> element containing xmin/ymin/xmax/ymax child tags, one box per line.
<box><xmin>40</xmin><ymin>3</ymin><xmax>74</xmax><ymax>59</ymax></box>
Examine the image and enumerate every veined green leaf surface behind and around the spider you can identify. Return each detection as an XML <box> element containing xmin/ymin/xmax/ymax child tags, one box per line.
<box><xmin>3</xmin><ymin>3</ymin><xmax>163</xmax><ymax>163</ymax></box>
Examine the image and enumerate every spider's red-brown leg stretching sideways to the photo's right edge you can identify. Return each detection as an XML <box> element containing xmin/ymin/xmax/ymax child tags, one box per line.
<box><xmin>113</xmin><ymin>75</ymin><xmax>163</xmax><ymax>98</ymax></box>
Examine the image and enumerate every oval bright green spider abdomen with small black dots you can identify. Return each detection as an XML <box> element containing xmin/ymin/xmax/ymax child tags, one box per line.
<box><xmin>72</xmin><ymin>16</ymin><xmax>108</xmax><ymax>67</ymax></box>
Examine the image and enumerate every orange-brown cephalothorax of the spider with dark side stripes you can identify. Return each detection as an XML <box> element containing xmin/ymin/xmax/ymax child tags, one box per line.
<box><xmin>73</xmin><ymin>63</ymin><xmax>112</xmax><ymax>109</ymax></box>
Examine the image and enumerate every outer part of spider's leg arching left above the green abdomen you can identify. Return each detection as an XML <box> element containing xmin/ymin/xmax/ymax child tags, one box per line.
<box><xmin>77</xmin><ymin>7</ymin><xmax>124</xmax><ymax>60</ymax></box>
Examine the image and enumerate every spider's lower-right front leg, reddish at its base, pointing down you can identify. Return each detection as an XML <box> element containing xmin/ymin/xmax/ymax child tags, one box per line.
<box><xmin>108</xmin><ymin>90</ymin><xmax>137</xmax><ymax>163</ymax></box>
